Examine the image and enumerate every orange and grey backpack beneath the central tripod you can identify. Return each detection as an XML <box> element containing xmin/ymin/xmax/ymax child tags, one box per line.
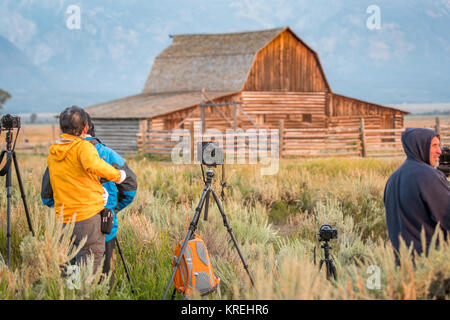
<box><xmin>172</xmin><ymin>233</ymin><xmax>220</xmax><ymax>297</ymax></box>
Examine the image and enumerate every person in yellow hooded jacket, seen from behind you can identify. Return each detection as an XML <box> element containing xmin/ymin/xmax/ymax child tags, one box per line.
<box><xmin>47</xmin><ymin>106</ymin><xmax>126</xmax><ymax>270</ymax></box>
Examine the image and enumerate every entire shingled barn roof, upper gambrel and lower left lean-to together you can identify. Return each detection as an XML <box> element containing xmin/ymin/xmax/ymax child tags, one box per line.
<box><xmin>86</xmin><ymin>27</ymin><xmax>407</xmax><ymax>119</ymax></box>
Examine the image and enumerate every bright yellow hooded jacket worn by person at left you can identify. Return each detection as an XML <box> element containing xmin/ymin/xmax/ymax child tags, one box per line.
<box><xmin>47</xmin><ymin>134</ymin><xmax>120</xmax><ymax>223</ymax></box>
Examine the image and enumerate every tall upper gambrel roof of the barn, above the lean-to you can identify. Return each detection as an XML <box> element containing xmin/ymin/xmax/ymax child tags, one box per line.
<box><xmin>143</xmin><ymin>27</ymin><xmax>328</xmax><ymax>93</ymax></box>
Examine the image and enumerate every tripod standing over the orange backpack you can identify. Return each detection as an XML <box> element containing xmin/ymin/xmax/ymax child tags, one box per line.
<box><xmin>163</xmin><ymin>167</ymin><xmax>255</xmax><ymax>300</ymax></box>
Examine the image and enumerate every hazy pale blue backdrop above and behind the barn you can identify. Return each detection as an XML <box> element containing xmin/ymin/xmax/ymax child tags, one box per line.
<box><xmin>0</xmin><ymin>0</ymin><xmax>450</xmax><ymax>112</ymax></box>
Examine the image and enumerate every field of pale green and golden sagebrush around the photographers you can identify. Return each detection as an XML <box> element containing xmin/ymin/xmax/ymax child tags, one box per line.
<box><xmin>0</xmin><ymin>153</ymin><xmax>450</xmax><ymax>299</ymax></box>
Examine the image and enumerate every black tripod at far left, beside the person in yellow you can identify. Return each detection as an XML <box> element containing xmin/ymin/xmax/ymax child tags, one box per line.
<box><xmin>0</xmin><ymin>128</ymin><xmax>34</xmax><ymax>267</ymax></box>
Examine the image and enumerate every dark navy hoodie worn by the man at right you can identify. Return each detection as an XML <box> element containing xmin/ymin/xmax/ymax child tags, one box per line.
<box><xmin>384</xmin><ymin>128</ymin><xmax>450</xmax><ymax>253</ymax></box>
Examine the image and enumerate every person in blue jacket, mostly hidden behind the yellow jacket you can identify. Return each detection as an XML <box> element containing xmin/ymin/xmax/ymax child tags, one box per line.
<box><xmin>41</xmin><ymin>116</ymin><xmax>137</xmax><ymax>279</ymax></box>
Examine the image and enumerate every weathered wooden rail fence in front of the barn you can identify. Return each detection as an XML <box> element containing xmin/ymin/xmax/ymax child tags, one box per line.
<box><xmin>138</xmin><ymin>119</ymin><xmax>450</xmax><ymax>157</ymax></box>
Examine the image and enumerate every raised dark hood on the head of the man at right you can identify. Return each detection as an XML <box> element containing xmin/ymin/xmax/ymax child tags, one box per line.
<box><xmin>402</xmin><ymin>128</ymin><xmax>439</xmax><ymax>164</ymax></box>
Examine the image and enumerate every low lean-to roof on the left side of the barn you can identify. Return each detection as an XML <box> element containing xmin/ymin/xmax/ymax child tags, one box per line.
<box><xmin>85</xmin><ymin>91</ymin><xmax>237</xmax><ymax>119</ymax></box>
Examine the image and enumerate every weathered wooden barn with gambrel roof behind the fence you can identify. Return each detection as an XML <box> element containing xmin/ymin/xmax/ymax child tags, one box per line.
<box><xmin>86</xmin><ymin>27</ymin><xmax>407</xmax><ymax>153</ymax></box>
